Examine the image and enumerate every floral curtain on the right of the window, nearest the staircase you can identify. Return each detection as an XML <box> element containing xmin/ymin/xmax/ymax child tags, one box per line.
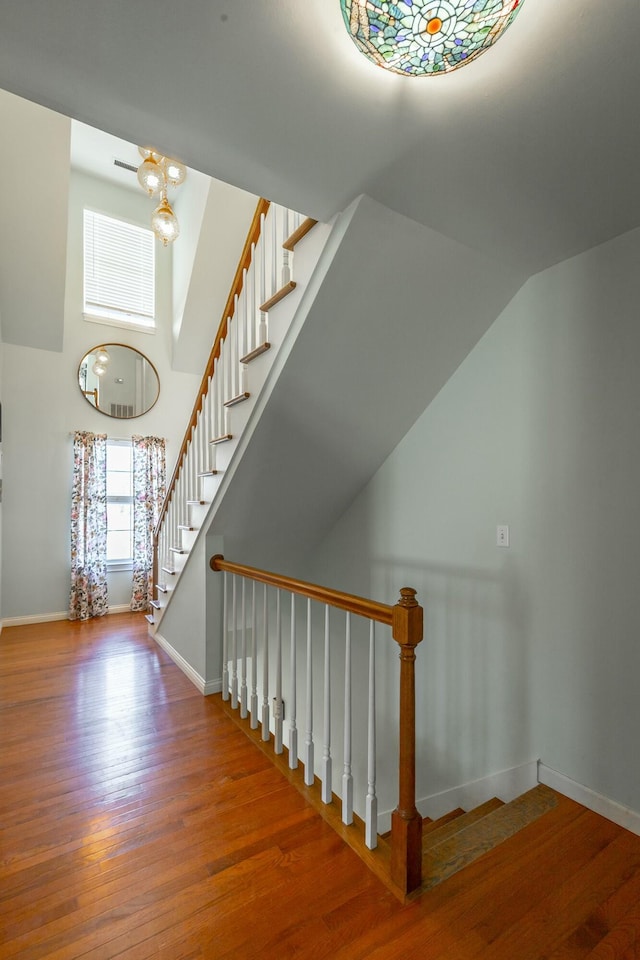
<box><xmin>131</xmin><ymin>437</ymin><xmax>166</xmax><ymax>610</ymax></box>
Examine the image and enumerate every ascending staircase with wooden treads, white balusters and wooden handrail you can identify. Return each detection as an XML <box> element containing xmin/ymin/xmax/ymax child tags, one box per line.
<box><xmin>146</xmin><ymin>200</ymin><xmax>327</xmax><ymax>635</ymax></box>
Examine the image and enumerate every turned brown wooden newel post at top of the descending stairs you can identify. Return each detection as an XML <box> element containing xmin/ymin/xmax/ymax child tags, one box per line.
<box><xmin>391</xmin><ymin>587</ymin><xmax>422</xmax><ymax>893</ymax></box>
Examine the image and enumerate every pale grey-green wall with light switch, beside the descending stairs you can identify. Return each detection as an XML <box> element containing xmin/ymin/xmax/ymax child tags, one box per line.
<box><xmin>310</xmin><ymin>225</ymin><xmax>640</xmax><ymax>811</ymax></box>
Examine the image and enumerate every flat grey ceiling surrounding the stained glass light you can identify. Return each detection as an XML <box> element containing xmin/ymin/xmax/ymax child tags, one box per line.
<box><xmin>0</xmin><ymin>0</ymin><xmax>640</xmax><ymax>277</ymax></box>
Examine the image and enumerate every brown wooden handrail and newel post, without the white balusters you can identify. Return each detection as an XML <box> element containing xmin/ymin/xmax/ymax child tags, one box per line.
<box><xmin>209</xmin><ymin>553</ymin><xmax>423</xmax><ymax>898</ymax></box>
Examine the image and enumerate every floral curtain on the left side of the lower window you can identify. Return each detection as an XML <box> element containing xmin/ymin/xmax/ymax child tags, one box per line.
<box><xmin>69</xmin><ymin>431</ymin><xmax>109</xmax><ymax>620</ymax></box>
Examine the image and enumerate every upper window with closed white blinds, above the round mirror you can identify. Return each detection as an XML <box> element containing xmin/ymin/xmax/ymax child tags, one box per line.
<box><xmin>84</xmin><ymin>209</ymin><xmax>156</xmax><ymax>333</ymax></box>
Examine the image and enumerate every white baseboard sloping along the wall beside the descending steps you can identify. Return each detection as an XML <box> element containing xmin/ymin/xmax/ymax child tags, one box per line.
<box><xmin>378</xmin><ymin>760</ymin><xmax>538</xmax><ymax>833</ymax></box>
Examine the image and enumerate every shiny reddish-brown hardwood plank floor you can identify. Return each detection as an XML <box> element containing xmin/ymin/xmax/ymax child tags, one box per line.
<box><xmin>0</xmin><ymin>614</ymin><xmax>640</xmax><ymax>960</ymax></box>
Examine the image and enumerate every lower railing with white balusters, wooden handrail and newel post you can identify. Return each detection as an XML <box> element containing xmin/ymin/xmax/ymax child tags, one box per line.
<box><xmin>210</xmin><ymin>554</ymin><xmax>423</xmax><ymax>895</ymax></box>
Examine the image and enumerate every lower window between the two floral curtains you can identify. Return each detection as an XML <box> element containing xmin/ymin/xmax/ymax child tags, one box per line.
<box><xmin>107</xmin><ymin>440</ymin><xmax>133</xmax><ymax>570</ymax></box>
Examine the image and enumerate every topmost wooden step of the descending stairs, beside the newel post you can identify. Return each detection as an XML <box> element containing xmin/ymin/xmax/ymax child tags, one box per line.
<box><xmin>422</xmin><ymin>784</ymin><xmax>558</xmax><ymax>890</ymax></box>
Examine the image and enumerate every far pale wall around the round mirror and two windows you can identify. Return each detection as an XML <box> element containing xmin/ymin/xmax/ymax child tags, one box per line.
<box><xmin>2</xmin><ymin>173</ymin><xmax>200</xmax><ymax>619</ymax></box>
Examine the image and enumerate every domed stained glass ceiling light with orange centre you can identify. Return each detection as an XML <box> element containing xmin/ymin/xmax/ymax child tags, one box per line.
<box><xmin>340</xmin><ymin>0</ymin><xmax>524</xmax><ymax>77</ymax></box>
